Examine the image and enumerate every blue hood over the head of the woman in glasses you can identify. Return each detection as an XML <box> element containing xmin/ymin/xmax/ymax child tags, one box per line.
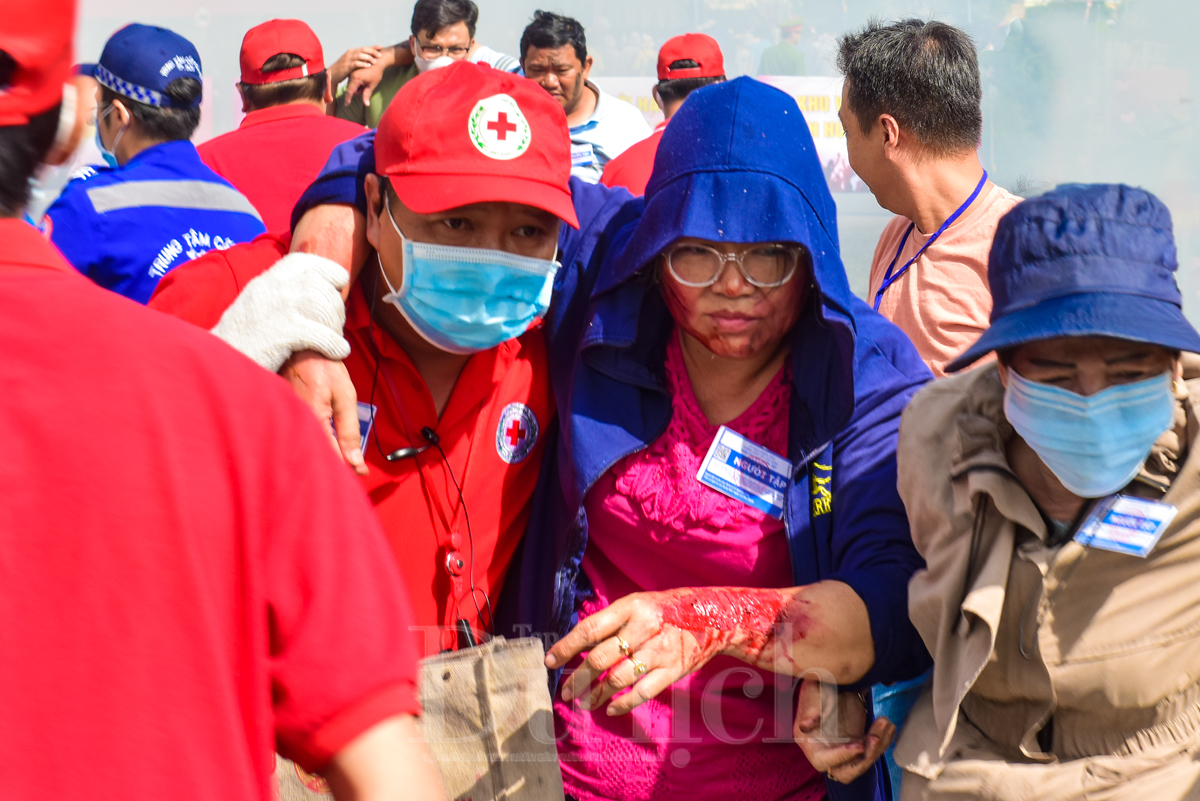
<box><xmin>613</xmin><ymin>78</ymin><xmax>850</xmax><ymax>309</ymax></box>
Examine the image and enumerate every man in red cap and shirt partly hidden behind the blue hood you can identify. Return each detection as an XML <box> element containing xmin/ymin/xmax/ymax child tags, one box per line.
<box><xmin>600</xmin><ymin>34</ymin><xmax>725</xmax><ymax>194</ymax></box>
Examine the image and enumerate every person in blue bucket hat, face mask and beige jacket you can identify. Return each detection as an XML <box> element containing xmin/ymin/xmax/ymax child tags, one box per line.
<box><xmin>896</xmin><ymin>185</ymin><xmax>1200</xmax><ymax>801</ymax></box>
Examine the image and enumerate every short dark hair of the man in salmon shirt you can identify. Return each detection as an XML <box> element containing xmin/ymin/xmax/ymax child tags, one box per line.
<box><xmin>838</xmin><ymin>19</ymin><xmax>983</xmax><ymax>156</ymax></box>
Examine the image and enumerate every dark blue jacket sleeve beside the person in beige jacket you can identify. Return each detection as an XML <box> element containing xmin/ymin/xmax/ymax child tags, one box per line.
<box><xmin>826</xmin><ymin>307</ymin><xmax>931</xmax><ymax>687</ymax></box>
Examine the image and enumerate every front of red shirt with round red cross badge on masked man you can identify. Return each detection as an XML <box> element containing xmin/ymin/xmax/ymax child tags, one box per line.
<box><xmin>346</xmin><ymin>281</ymin><xmax>554</xmax><ymax>655</ymax></box>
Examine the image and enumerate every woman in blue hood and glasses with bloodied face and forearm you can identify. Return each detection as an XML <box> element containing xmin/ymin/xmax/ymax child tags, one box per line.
<box><xmin>499</xmin><ymin>79</ymin><xmax>929</xmax><ymax>800</ymax></box>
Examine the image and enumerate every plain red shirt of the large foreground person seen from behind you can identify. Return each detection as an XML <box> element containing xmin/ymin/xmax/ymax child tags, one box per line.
<box><xmin>0</xmin><ymin>219</ymin><xmax>418</xmax><ymax>801</ymax></box>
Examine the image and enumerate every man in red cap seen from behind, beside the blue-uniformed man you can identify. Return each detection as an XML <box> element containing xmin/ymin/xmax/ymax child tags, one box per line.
<box><xmin>197</xmin><ymin>19</ymin><xmax>364</xmax><ymax>233</ymax></box>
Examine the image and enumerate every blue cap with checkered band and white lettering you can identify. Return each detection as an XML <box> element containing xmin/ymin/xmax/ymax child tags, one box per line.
<box><xmin>79</xmin><ymin>23</ymin><xmax>203</xmax><ymax>108</ymax></box>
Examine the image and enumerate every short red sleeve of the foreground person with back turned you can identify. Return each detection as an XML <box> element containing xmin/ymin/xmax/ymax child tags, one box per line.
<box><xmin>264</xmin><ymin>408</ymin><xmax>420</xmax><ymax>771</ymax></box>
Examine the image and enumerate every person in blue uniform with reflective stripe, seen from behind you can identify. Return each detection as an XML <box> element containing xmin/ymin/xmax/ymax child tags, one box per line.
<box><xmin>43</xmin><ymin>24</ymin><xmax>265</xmax><ymax>303</ymax></box>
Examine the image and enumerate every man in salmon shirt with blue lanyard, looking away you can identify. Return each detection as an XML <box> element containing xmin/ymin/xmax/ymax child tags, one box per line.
<box><xmin>838</xmin><ymin>19</ymin><xmax>1020</xmax><ymax>378</ymax></box>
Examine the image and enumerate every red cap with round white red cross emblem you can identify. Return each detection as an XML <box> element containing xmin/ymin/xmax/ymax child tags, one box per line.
<box><xmin>376</xmin><ymin>61</ymin><xmax>580</xmax><ymax>228</ymax></box>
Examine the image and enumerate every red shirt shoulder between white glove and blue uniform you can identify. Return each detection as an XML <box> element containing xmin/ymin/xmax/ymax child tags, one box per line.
<box><xmin>146</xmin><ymin>233</ymin><xmax>292</xmax><ymax>329</ymax></box>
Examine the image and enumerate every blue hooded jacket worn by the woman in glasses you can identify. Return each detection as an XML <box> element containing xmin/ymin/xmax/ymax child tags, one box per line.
<box><xmin>497</xmin><ymin>78</ymin><xmax>930</xmax><ymax>799</ymax></box>
